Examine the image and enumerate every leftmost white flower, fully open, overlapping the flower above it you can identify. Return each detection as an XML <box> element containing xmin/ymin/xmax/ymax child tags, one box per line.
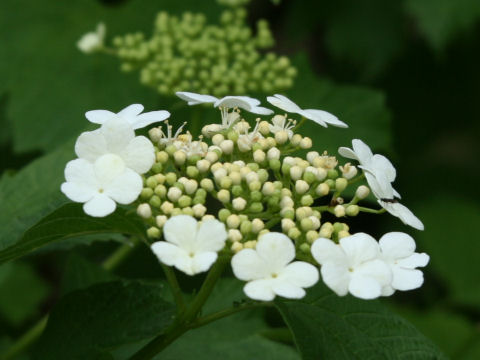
<box><xmin>61</xmin><ymin>154</ymin><xmax>143</xmax><ymax>217</ymax></box>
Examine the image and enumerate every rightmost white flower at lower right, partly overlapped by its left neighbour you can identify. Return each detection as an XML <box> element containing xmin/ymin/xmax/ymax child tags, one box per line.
<box><xmin>379</xmin><ymin>232</ymin><xmax>430</xmax><ymax>296</ymax></box>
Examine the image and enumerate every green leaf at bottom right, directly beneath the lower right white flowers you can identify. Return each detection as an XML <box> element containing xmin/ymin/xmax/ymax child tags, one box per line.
<box><xmin>276</xmin><ymin>285</ymin><xmax>446</xmax><ymax>360</ymax></box>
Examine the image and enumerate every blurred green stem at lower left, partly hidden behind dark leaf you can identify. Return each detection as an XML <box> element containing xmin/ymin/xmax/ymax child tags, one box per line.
<box><xmin>0</xmin><ymin>238</ymin><xmax>139</xmax><ymax>360</ymax></box>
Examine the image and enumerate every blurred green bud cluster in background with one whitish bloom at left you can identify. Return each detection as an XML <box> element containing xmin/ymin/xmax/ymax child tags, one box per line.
<box><xmin>79</xmin><ymin>0</ymin><xmax>296</xmax><ymax>96</ymax></box>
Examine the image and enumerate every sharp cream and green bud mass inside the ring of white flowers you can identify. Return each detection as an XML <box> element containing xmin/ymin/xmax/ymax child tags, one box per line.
<box><xmin>133</xmin><ymin>94</ymin><xmax>376</xmax><ymax>259</ymax></box>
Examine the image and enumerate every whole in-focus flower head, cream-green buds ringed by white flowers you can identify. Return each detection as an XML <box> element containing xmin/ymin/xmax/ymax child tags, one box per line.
<box><xmin>62</xmin><ymin>92</ymin><xmax>429</xmax><ymax>301</ymax></box>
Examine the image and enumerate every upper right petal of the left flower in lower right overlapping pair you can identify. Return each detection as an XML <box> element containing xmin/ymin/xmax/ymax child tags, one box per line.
<box><xmin>340</xmin><ymin>233</ymin><xmax>379</xmax><ymax>266</ymax></box>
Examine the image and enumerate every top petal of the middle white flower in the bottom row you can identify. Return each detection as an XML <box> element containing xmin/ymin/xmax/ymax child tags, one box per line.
<box><xmin>256</xmin><ymin>232</ymin><xmax>295</xmax><ymax>273</ymax></box>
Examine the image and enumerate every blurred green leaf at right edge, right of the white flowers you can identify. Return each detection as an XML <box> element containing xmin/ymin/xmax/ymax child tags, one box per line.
<box><xmin>416</xmin><ymin>198</ymin><xmax>480</xmax><ymax>308</ymax></box>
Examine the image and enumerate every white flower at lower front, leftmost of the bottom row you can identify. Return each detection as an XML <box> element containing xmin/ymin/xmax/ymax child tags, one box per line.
<box><xmin>151</xmin><ymin>215</ymin><xmax>227</xmax><ymax>275</ymax></box>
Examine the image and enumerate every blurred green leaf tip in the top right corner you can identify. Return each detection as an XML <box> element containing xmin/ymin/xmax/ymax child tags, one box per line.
<box><xmin>405</xmin><ymin>0</ymin><xmax>480</xmax><ymax>50</ymax></box>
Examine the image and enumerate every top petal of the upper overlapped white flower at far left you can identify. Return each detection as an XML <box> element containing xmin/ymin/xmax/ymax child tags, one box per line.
<box><xmin>100</xmin><ymin>116</ymin><xmax>135</xmax><ymax>153</ymax></box>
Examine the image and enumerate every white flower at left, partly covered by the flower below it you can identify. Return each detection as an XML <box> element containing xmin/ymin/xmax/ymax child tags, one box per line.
<box><xmin>75</xmin><ymin>117</ymin><xmax>155</xmax><ymax>174</ymax></box>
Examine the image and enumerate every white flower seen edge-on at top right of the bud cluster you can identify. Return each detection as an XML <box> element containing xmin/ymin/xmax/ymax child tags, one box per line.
<box><xmin>267</xmin><ymin>94</ymin><xmax>348</xmax><ymax>128</ymax></box>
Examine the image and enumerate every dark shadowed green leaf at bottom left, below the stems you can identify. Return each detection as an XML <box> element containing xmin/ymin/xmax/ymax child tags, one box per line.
<box><xmin>34</xmin><ymin>281</ymin><xmax>175</xmax><ymax>360</ymax></box>
